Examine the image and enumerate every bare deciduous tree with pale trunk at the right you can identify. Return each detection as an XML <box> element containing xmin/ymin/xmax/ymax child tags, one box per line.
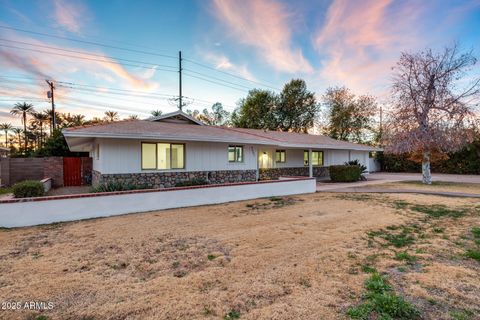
<box><xmin>385</xmin><ymin>45</ymin><xmax>480</xmax><ymax>184</ymax></box>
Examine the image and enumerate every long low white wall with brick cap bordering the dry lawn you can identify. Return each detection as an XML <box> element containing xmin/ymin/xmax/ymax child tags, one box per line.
<box><xmin>0</xmin><ymin>178</ymin><xmax>316</xmax><ymax>227</ymax></box>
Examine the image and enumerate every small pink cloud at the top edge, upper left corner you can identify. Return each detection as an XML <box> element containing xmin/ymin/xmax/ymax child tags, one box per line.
<box><xmin>53</xmin><ymin>0</ymin><xmax>88</xmax><ymax>33</ymax></box>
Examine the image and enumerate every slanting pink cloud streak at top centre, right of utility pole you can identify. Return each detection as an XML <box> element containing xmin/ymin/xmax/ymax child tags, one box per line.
<box><xmin>213</xmin><ymin>0</ymin><xmax>313</xmax><ymax>73</ymax></box>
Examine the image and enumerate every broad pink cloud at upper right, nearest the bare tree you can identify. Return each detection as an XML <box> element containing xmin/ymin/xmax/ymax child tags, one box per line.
<box><xmin>314</xmin><ymin>0</ymin><xmax>425</xmax><ymax>91</ymax></box>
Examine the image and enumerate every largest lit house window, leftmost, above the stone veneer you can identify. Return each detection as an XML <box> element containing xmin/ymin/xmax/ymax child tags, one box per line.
<box><xmin>142</xmin><ymin>142</ymin><xmax>185</xmax><ymax>170</ymax></box>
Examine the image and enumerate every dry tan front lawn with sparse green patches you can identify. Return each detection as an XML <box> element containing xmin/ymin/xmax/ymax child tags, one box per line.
<box><xmin>0</xmin><ymin>193</ymin><xmax>480</xmax><ymax>320</ymax></box>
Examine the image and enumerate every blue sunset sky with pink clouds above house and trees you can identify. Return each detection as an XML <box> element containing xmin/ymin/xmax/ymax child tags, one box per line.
<box><xmin>0</xmin><ymin>0</ymin><xmax>480</xmax><ymax>126</ymax></box>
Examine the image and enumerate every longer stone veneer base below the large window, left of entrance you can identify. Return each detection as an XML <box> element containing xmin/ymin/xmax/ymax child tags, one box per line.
<box><xmin>92</xmin><ymin>170</ymin><xmax>256</xmax><ymax>188</ymax></box>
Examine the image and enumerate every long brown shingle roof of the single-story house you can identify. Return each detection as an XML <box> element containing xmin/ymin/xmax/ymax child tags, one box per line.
<box><xmin>63</xmin><ymin>120</ymin><xmax>376</xmax><ymax>150</ymax></box>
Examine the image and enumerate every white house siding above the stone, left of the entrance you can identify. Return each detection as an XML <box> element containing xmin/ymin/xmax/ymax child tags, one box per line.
<box><xmin>91</xmin><ymin>139</ymin><xmax>257</xmax><ymax>174</ymax></box>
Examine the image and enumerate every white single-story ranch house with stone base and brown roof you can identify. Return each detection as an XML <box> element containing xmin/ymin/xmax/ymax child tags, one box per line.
<box><xmin>62</xmin><ymin>111</ymin><xmax>378</xmax><ymax>188</ymax></box>
